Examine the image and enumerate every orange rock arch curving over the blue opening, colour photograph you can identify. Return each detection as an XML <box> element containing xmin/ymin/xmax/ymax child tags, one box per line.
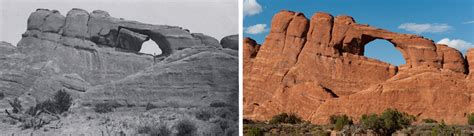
<box><xmin>331</xmin><ymin>16</ymin><xmax>441</xmax><ymax>68</ymax></box>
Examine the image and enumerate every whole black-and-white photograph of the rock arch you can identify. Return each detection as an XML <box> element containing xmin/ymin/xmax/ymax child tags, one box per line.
<box><xmin>0</xmin><ymin>0</ymin><xmax>239</xmax><ymax>136</ymax></box>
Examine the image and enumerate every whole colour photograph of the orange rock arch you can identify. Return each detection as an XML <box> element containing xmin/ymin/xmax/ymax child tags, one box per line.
<box><xmin>242</xmin><ymin>0</ymin><xmax>474</xmax><ymax>136</ymax></box>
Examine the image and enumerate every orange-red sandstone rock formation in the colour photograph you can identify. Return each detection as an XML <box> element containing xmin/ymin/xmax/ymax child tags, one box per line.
<box><xmin>243</xmin><ymin>10</ymin><xmax>474</xmax><ymax>124</ymax></box>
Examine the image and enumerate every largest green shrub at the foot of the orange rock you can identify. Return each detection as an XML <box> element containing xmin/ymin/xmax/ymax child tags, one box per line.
<box><xmin>360</xmin><ymin>109</ymin><xmax>415</xmax><ymax>135</ymax></box>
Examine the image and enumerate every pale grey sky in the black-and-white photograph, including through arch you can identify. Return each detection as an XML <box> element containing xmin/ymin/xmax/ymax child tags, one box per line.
<box><xmin>0</xmin><ymin>0</ymin><xmax>239</xmax><ymax>54</ymax></box>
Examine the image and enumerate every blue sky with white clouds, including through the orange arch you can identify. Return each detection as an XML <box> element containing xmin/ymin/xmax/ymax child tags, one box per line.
<box><xmin>243</xmin><ymin>0</ymin><xmax>474</xmax><ymax>65</ymax></box>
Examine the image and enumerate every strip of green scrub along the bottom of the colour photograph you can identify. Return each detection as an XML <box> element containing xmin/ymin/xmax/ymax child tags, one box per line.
<box><xmin>244</xmin><ymin>109</ymin><xmax>474</xmax><ymax>136</ymax></box>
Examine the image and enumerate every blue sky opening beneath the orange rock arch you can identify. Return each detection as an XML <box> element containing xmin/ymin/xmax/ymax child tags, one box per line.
<box><xmin>364</xmin><ymin>39</ymin><xmax>406</xmax><ymax>66</ymax></box>
